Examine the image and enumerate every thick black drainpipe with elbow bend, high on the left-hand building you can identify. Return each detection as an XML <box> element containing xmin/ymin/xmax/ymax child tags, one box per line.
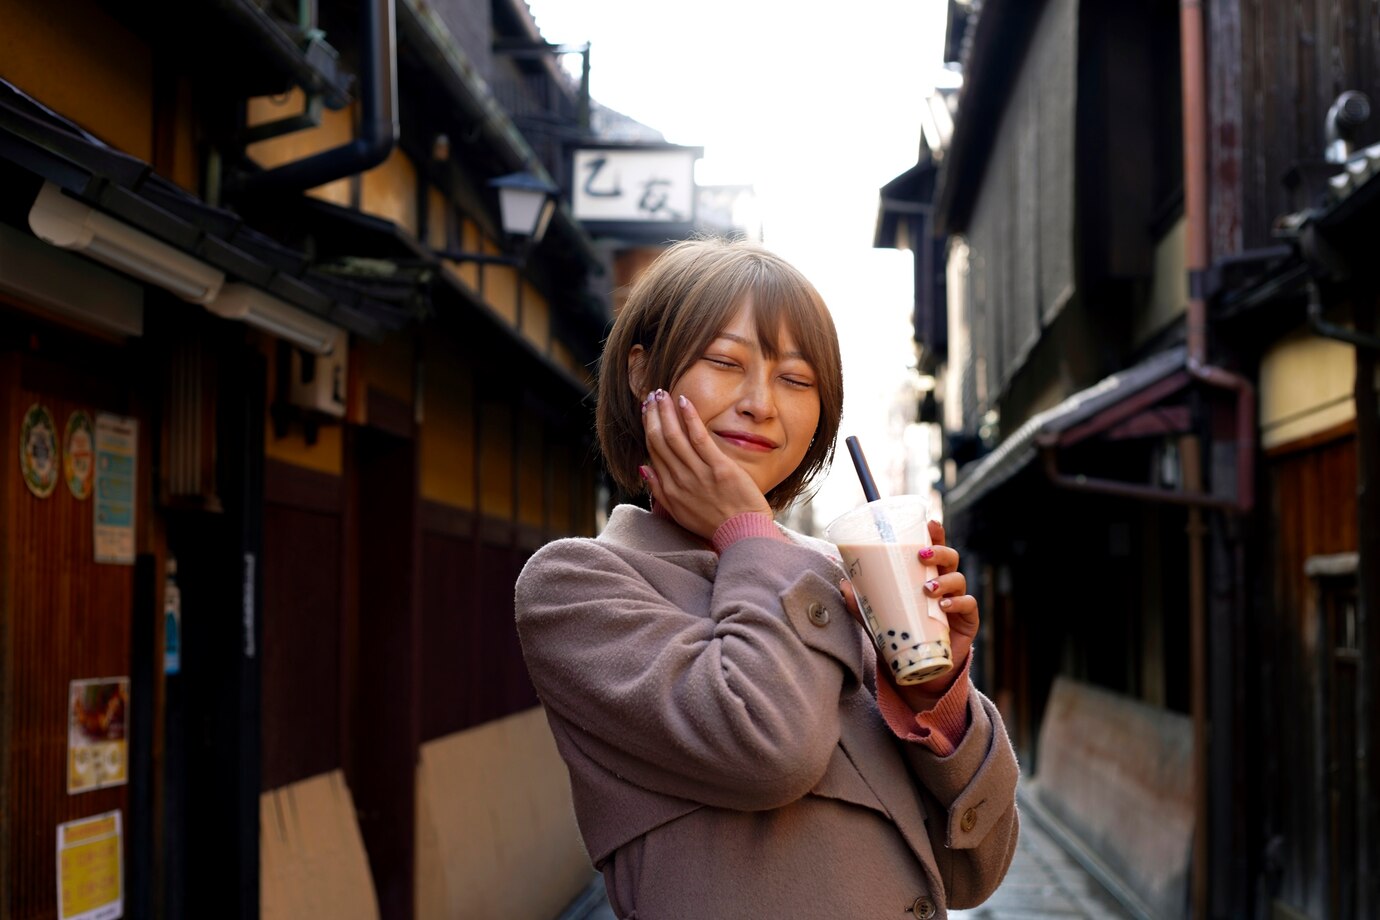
<box><xmin>237</xmin><ymin>0</ymin><xmax>399</xmax><ymax>194</ymax></box>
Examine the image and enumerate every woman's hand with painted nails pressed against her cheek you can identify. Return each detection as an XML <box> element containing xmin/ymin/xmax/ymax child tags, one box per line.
<box><xmin>642</xmin><ymin>390</ymin><xmax>771</xmax><ymax>539</ymax></box>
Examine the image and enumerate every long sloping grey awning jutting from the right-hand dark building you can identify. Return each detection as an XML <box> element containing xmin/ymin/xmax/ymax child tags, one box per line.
<box><xmin>944</xmin><ymin>346</ymin><xmax>1192</xmax><ymax>514</ymax></box>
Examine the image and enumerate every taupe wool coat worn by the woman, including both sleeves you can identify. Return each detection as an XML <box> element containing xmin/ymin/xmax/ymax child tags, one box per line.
<box><xmin>516</xmin><ymin>505</ymin><xmax>1018</xmax><ymax>920</ymax></box>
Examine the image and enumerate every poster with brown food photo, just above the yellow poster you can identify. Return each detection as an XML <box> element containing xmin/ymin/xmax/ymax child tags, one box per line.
<box><xmin>68</xmin><ymin>677</ymin><xmax>130</xmax><ymax>794</ymax></box>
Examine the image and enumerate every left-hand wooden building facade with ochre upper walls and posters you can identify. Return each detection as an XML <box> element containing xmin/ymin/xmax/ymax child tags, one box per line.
<box><xmin>0</xmin><ymin>0</ymin><xmax>611</xmax><ymax>920</ymax></box>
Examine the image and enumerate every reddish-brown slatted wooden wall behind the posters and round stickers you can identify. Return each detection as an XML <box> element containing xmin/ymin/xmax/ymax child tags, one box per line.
<box><xmin>0</xmin><ymin>352</ymin><xmax>138</xmax><ymax>920</ymax></box>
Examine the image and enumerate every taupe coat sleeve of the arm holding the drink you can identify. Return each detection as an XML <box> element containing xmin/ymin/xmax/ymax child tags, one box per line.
<box><xmin>904</xmin><ymin>688</ymin><xmax>1020</xmax><ymax>908</ymax></box>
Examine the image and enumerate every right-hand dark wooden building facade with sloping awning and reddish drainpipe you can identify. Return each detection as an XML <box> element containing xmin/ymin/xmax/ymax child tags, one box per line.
<box><xmin>883</xmin><ymin>0</ymin><xmax>1380</xmax><ymax>920</ymax></box>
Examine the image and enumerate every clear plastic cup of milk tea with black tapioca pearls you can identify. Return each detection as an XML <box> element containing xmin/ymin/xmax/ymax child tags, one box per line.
<box><xmin>825</xmin><ymin>495</ymin><xmax>954</xmax><ymax>684</ymax></box>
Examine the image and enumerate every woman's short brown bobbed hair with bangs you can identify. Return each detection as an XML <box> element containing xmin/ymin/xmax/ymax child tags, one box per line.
<box><xmin>598</xmin><ymin>240</ymin><xmax>843</xmax><ymax>512</ymax></box>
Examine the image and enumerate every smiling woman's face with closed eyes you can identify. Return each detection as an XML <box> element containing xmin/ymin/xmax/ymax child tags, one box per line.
<box><xmin>671</xmin><ymin>301</ymin><xmax>820</xmax><ymax>494</ymax></box>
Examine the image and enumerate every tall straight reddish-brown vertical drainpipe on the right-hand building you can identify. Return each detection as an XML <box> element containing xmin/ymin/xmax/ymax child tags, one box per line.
<box><xmin>1179</xmin><ymin>0</ymin><xmax>1208</xmax><ymax>920</ymax></box>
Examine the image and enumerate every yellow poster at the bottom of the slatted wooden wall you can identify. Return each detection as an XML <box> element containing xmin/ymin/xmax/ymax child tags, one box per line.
<box><xmin>58</xmin><ymin>811</ymin><xmax>124</xmax><ymax>920</ymax></box>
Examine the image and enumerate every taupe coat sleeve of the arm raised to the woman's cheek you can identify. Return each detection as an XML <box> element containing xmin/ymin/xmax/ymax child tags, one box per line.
<box><xmin>516</xmin><ymin>538</ymin><xmax>864</xmax><ymax>810</ymax></box>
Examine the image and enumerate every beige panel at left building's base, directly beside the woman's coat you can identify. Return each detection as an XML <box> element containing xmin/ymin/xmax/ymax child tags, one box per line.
<box><xmin>417</xmin><ymin>708</ymin><xmax>593</xmax><ymax>920</ymax></box>
